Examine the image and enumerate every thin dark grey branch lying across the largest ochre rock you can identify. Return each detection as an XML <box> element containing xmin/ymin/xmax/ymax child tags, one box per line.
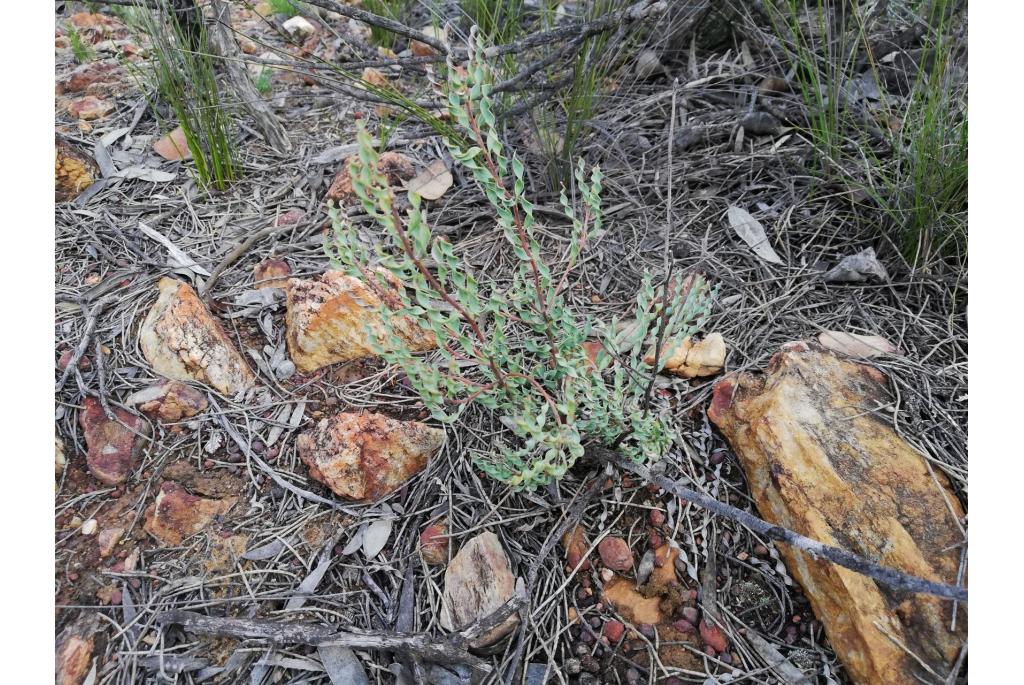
<box><xmin>588</xmin><ymin>446</ymin><xmax>967</xmax><ymax>602</ymax></box>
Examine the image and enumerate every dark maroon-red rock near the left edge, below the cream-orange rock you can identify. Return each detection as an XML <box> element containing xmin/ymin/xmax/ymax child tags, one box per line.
<box><xmin>79</xmin><ymin>397</ymin><xmax>150</xmax><ymax>485</ymax></box>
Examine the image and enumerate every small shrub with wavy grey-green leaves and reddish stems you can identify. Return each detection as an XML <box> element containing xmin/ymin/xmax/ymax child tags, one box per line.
<box><xmin>327</xmin><ymin>31</ymin><xmax>710</xmax><ymax>487</ymax></box>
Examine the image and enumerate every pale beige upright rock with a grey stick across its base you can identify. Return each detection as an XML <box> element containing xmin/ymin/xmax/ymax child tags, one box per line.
<box><xmin>440</xmin><ymin>530</ymin><xmax>519</xmax><ymax>648</ymax></box>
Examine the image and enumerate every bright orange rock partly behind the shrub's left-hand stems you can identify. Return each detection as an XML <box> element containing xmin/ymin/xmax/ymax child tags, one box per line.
<box><xmin>285</xmin><ymin>271</ymin><xmax>437</xmax><ymax>374</ymax></box>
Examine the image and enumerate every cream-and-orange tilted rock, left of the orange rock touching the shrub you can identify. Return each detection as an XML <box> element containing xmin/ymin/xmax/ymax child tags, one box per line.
<box><xmin>139</xmin><ymin>277</ymin><xmax>256</xmax><ymax>395</ymax></box>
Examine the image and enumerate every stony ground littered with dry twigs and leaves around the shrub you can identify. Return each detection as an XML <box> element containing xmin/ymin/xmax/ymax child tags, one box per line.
<box><xmin>54</xmin><ymin>3</ymin><xmax>967</xmax><ymax>685</ymax></box>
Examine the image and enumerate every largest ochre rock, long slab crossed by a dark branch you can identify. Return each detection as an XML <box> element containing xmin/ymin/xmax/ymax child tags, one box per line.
<box><xmin>708</xmin><ymin>343</ymin><xmax>967</xmax><ymax>685</ymax></box>
